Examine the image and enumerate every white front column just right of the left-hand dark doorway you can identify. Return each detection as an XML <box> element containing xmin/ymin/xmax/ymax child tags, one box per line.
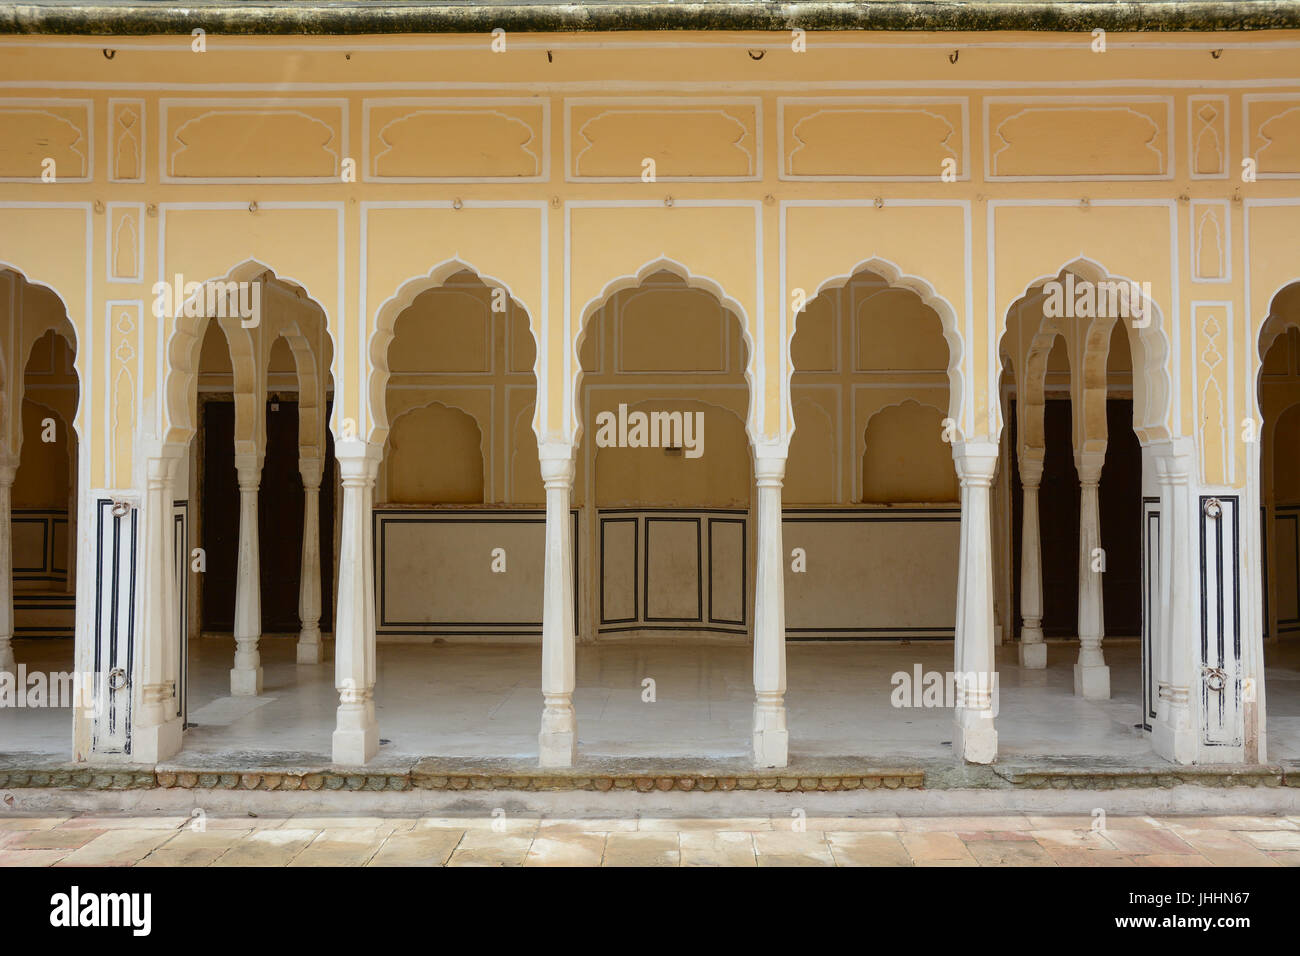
<box><xmin>333</xmin><ymin>438</ymin><xmax>380</xmax><ymax>766</ymax></box>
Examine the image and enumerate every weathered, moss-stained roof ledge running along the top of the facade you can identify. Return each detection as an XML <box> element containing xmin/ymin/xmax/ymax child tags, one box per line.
<box><xmin>0</xmin><ymin>0</ymin><xmax>1300</xmax><ymax>36</ymax></box>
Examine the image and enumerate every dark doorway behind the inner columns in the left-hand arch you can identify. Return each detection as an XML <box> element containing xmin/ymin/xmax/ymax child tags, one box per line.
<box><xmin>200</xmin><ymin>401</ymin><xmax>334</xmax><ymax>633</ymax></box>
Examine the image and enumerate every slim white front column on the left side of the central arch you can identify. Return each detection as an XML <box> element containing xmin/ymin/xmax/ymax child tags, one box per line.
<box><xmin>537</xmin><ymin>445</ymin><xmax>577</xmax><ymax>767</ymax></box>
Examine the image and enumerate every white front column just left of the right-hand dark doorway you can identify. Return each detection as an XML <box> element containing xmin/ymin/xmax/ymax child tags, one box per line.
<box><xmin>953</xmin><ymin>441</ymin><xmax>997</xmax><ymax>763</ymax></box>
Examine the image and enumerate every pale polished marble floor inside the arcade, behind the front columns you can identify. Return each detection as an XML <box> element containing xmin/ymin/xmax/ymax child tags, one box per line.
<box><xmin>10</xmin><ymin>636</ymin><xmax>1300</xmax><ymax>763</ymax></box>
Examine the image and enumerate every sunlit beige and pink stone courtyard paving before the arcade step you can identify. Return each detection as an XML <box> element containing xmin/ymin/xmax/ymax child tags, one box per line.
<box><xmin>0</xmin><ymin>810</ymin><xmax>1300</xmax><ymax>866</ymax></box>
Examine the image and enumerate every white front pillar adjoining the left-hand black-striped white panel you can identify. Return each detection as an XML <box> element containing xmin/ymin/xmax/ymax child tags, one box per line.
<box><xmin>131</xmin><ymin>446</ymin><xmax>183</xmax><ymax>763</ymax></box>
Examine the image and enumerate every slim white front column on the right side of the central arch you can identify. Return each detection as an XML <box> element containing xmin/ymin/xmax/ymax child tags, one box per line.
<box><xmin>754</xmin><ymin>446</ymin><xmax>790</xmax><ymax>767</ymax></box>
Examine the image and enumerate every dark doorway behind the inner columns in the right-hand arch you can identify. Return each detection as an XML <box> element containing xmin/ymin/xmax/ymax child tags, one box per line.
<box><xmin>1008</xmin><ymin>398</ymin><xmax>1141</xmax><ymax>637</ymax></box>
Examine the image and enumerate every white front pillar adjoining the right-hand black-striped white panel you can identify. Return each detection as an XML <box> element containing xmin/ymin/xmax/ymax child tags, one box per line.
<box><xmin>1151</xmin><ymin>438</ymin><xmax>1200</xmax><ymax>763</ymax></box>
